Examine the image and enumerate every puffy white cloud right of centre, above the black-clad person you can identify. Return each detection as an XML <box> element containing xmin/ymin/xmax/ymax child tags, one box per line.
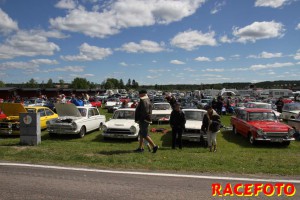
<box><xmin>171</xmin><ymin>30</ymin><xmax>217</xmax><ymax>51</ymax></box>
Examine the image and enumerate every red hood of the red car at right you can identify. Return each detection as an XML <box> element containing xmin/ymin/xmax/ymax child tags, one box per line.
<box><xmin>249</xmin><ymin>121</ymin><xmax>289</xmax><ymax>132</ymax></box>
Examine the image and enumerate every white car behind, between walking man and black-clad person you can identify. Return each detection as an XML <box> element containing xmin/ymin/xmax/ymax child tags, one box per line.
<box><xmin>152</xmin><ymin>102</ymin><xmax>172</xmax><ymax>123</ymax></box>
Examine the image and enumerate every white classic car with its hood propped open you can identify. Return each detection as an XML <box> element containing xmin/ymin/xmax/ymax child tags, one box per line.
<box><xmin>47</xmin><ymin>103</ymin><xmax>106</xmax><ymax>138</ymax></box>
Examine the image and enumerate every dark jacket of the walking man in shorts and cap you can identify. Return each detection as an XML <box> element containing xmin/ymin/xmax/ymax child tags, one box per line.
<box><xmin>135</xmin><ymin>96</ymin><xmax>152</xmax><ymax>122</ymax></box>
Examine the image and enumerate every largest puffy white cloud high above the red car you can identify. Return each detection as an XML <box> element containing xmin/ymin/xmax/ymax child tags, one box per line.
<box><xmin>233</xmin><ymin>21</ymin><xmax>285</xmax><ymax>43</ymax></box>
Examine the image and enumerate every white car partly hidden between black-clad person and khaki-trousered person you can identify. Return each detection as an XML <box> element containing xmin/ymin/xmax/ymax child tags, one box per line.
<box><xmin>182</xmin><ymin>109</ymin><xmax>207</xmax><ymax>146</ymax></box>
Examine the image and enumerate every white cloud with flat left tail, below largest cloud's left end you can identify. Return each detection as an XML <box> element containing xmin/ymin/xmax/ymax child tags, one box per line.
<box><xmin>61</xmin><ymin>43</ymin><xmax>112</xmax><ymax>61</ymax></box>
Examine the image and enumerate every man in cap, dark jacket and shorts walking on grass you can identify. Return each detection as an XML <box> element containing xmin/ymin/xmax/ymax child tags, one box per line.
<box><xmin>135</xmin><ymin>90</ymin><xmax>159</xmax><ymax>153</ymax></box>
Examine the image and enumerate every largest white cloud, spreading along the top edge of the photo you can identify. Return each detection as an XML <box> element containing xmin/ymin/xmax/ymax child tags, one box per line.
<box><xmin>50</xmin><ymin>0</ymin><xmax>205</xmax><ymax>38</ymax></box>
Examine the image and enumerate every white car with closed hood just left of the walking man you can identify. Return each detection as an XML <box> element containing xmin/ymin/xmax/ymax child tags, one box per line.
<box><xmin>103</xmin><ymin>108</ymin><xmax>140</xmax><ymax>139</ymax></box>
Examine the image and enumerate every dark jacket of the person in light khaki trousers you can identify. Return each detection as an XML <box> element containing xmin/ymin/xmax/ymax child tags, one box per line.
<box><xmin>201</xmin><ymin>111</ymin><xmax>222</xmax><ymax>132</ymax></box>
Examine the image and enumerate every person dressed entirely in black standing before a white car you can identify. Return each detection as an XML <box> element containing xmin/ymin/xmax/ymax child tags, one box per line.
<box><xmin>170</xmin><ymin>103</ymin><xmax>186</xmax><ymax>149</ymax></box>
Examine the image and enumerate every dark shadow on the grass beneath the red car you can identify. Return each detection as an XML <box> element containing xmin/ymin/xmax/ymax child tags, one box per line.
<box><xmin>221</xmin><ymin>130</ymin><xmax>288</xmax><ymax>148</ymax></box>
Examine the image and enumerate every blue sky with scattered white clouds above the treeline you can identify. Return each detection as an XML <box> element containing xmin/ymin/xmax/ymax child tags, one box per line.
<box><xmin>0</xmin><ymin>0</ymin><xmax>300</xmax><ymax>85</ymax></box>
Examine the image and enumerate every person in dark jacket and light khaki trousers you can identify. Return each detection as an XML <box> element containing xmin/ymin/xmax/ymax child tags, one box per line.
<box><xmin>201</xmin><ymin>106</ymin><xmax>221</xmax><ymax>152</ymax></box>
